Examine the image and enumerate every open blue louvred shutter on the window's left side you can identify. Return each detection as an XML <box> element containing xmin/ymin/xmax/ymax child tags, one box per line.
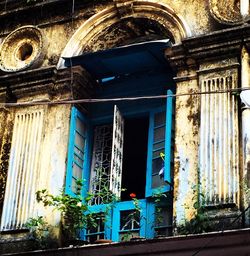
<box><xmin>65</xmin><ymin>107</ymin><xmax>89</xmax><ymax>195</ymax></box>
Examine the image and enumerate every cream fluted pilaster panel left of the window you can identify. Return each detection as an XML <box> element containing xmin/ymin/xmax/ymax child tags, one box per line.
<box><xmin>1</xmin><ymin>111</ymin><xmax>43</xmax><ymax>230</ymax></box>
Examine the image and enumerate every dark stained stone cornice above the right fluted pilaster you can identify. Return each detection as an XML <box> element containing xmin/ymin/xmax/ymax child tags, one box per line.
<box><xmin>166</xmin><ymin>24</ymin><xmax>250</xmax><ymax>70</ymax></box>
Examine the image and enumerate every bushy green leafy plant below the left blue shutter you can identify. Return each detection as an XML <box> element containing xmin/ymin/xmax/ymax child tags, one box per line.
<box><xmin>36</xmin><ymin>180</ymin><xmax>96</xmax><ymax>239</ymax></box>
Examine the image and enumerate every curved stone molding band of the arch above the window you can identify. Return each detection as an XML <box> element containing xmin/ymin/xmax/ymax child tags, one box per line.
<box><xmin>57</xmin><ymin>0</ymin><xmax>191</xmax><ymax>69</ymax></box>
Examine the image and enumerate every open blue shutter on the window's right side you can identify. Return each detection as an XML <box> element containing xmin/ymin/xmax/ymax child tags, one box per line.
<box><xmin>146</xmin><ymin>90</ymin><xmax>173</xmax><ymax>197</ymax></box>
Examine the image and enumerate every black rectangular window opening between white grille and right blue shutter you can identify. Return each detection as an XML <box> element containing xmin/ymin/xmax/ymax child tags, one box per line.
<box><xmin>121</xmin><ymin>117</ymin><xmax>149</xmax><ymax>201</ymax></box>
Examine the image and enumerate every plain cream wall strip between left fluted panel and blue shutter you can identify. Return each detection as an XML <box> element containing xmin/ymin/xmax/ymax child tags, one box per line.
<box><xmin>38</xmin><ymin>105</ymin><xmax>71</xmax><ymax>227</ymax></box>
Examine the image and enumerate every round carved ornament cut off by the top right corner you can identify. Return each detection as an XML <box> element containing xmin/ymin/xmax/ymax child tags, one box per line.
<box><xmin>209</xmin><ymin>0</ymin><xmax>250</xmax><ymax>25</ymax></box>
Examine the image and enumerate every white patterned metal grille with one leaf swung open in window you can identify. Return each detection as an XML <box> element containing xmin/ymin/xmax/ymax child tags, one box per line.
<box><xmin>90</xmin><ymin>105</ymin><xmax>124</xmax><ymax>205</ymax></box>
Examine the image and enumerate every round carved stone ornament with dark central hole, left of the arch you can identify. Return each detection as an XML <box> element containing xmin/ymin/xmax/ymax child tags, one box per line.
<box><xmin>0</xmin><ymin>26</ymin><xmax>45</xmax><ymax>72</ymax></box>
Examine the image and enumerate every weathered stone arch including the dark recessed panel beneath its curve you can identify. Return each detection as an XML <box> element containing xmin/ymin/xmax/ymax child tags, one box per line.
<box><xmin>57</xmin><ymin>0</ymin><xmax>191</xmax><ymax>68</ymax></box>
